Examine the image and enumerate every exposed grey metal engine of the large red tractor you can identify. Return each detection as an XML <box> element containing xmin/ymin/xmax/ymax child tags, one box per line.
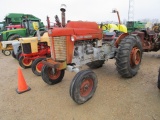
<box><xmin>72</xmin><ymin>40</ymin><xmax>112</xmax><ymax>65</ymax></box>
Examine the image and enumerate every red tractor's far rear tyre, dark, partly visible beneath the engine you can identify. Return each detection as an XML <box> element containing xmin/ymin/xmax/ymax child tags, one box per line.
<box><xmin>86</xmin><ymin>60</ymin><xmax>105</xmax><ymax>69</ymax></box>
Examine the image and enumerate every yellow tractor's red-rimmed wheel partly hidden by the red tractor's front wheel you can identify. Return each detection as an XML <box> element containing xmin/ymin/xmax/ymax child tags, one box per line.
<box><xmin>31</xmin><ymin>58</ymin><xmax>46</xmax><ymax>76</ymax></box>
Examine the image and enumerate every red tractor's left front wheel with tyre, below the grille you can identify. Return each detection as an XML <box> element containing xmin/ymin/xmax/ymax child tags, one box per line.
<box><xmin>41</xmin><ymin>65</ymin><xmax>65</xmax><ymax>85</ymax></box>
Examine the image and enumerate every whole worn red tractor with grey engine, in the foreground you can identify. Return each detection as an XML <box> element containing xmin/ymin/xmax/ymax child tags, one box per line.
<box><xmin>41</xmin><ymin>4</ymin><xmax>142</xmax><ymax>104</ymax></box>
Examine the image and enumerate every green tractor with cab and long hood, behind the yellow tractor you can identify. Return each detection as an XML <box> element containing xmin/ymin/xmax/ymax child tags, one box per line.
<box><xmin>0</xmin><ymin>15</ymin><xmax>45</xmax><ymax>41</ymax></box>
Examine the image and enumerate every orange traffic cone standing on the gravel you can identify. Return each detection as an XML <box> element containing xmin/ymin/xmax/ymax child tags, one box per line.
<box><xmin>16</xmin><ymin>67</ymin><xmax>31</xmax><ymax>94</ymax></box>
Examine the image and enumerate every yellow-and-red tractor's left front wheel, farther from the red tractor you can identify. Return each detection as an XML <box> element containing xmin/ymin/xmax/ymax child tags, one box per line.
<box><xmin>19</xmin><ymin>56</ymin><xmax>33</xmax><ymax>69</ymax></box>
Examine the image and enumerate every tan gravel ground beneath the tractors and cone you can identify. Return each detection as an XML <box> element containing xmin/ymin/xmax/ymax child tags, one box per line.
<box><xmin>0</xmin><ymin>51</ymin><xmax>160</xmax><ymax>120</ymax></box>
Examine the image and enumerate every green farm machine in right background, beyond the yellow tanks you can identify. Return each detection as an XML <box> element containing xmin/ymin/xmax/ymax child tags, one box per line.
<box><xmin>126</xmin><ymin>21</ymin><xmax>146</xmax><ymax>32</ymax></box>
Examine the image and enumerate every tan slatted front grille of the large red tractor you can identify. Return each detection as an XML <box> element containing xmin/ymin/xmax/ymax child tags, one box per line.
<box><xmin>54</xmin><ymin>36</ymin><xmax>67</xmax><ymax>61</ymax></box>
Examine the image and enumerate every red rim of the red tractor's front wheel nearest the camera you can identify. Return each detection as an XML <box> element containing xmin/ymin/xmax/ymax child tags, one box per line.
<box><xmin>80</xmin><ymin>78</ymin><xmax>93</xmax><ymax>97</ymax></box>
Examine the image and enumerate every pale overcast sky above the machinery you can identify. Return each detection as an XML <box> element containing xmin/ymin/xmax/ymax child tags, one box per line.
<box><xmin>0</xmin><ymin>0</ymin><xmax>160</xmax><ymax>24</ymax></box>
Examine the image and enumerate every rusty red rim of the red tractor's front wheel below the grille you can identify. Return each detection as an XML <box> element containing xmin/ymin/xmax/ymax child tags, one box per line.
<box><xmin>48</xmin><ymin>68</ymin><xmax>61</xmax><ymax>80</ymax></box>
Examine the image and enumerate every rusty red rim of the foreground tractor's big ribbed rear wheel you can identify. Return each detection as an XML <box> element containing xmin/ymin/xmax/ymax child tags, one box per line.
<box><xmin>131</xmin><ymin>47</ymin><xmax>141</xmax><ymax>65</ymax></box>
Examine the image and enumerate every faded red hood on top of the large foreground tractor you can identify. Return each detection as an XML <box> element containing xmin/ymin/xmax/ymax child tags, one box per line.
<box><xmin>49</xmin><ymin>21</ymin><xmax>103</xmax><ymax>38</ymax></box>
